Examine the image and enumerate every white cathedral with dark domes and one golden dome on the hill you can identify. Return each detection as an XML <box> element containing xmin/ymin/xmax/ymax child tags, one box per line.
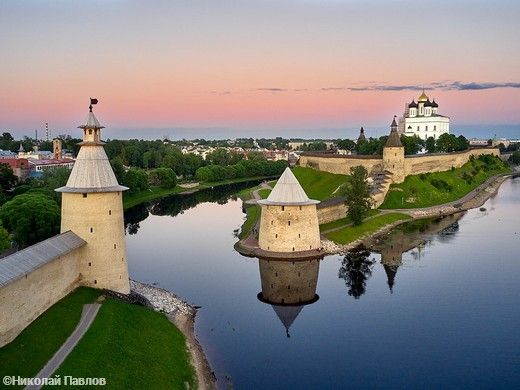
<box><xmin>398</xmin><ymin>91</ymin><xmax>450</xmax><ymax>139</ymax></box>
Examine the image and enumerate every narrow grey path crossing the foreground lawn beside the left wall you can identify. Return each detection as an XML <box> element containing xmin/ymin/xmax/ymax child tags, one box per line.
<box><xmin>26</xmin><ymin>303</ymin><xmax>101</xmax><ymax>390</ymax></box>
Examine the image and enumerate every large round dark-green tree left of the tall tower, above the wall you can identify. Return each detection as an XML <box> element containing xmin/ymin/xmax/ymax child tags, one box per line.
<box><xmin>0</xmin><ymin>192</ymin><xmax>60</xmax><ymax>247</ymax></box>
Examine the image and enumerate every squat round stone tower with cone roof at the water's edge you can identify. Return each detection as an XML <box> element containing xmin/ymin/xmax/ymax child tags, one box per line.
<box><xmin>258</xmin><ymin>168</ymin><xmax>321</xmax><ymax>252</ymax></box>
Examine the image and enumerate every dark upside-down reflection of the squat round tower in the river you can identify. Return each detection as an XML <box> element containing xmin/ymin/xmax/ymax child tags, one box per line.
<box><xmin>258</xmin><ymin>259</ymin><xmax>322</xmax><ymax>337</ymax></box>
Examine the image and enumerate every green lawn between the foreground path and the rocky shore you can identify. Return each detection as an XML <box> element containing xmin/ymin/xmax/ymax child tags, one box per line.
<box><xmin>50</xmin><ymin>298</ymin><xmax>196</xmax><ymax>389</ymax></box>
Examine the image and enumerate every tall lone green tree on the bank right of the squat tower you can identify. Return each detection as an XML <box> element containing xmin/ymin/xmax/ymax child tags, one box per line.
<box><xmin>344</xmin><ymin>165</ymin><xmax>372</xmax><ymax>225</ymax></box>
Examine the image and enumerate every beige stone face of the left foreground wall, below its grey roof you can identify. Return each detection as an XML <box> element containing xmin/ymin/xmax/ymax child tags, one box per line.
<box><xmin>0</xmin><ymin>247</ymin><xmax>83</xmax><ymax>347</ymax></box>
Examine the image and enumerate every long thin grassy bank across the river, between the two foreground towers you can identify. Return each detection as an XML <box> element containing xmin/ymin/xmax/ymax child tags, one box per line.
<box><xmin>123</xmin><ymin>176</ymin><xmax>270</xmax><ymax>210</ymax></box>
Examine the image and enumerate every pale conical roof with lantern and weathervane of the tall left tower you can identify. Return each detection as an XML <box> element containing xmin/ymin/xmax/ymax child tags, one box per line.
<box><xmin>56</xmin><ymin>100</ymin><xmax>128</xmax><ymax>193</ymax></box>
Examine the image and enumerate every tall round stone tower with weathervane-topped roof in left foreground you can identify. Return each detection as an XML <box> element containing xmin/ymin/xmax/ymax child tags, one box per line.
<box><xmin>56</xmin><ymin>101</ymin><xmax>130</xmax><ymax>294</ymax></box>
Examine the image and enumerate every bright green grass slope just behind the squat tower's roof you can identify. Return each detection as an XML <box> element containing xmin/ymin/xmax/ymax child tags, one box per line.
<box><xmin>292</xmin><ymin>167</ymin><xmax>348</xmax><ymax>200</ymax></box>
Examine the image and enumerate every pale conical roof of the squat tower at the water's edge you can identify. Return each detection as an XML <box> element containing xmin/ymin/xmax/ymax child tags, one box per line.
<box><xmin>258</xmin><ymin>168</ymin><xmax>320</xmax><ymax>206</ymax></box>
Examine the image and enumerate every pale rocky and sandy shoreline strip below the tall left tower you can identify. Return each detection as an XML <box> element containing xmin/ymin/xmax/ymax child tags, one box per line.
<box><xmin>130</xmin><ymin>280</ymin><xmax>216</xmax><ymax>390</ymax></box>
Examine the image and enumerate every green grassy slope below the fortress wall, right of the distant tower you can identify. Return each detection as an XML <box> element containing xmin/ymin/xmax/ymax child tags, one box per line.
<box><xmin>380</xmin><ymin>158</ymin><xmax>510</xmax><ymax>209</ymax></box>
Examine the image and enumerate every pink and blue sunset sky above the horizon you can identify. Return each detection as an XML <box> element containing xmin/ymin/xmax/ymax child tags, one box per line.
<box><xmin>0</xmin><ymin>0</ymin><xmax>520</xmax><ymax>138</ymax></box>
